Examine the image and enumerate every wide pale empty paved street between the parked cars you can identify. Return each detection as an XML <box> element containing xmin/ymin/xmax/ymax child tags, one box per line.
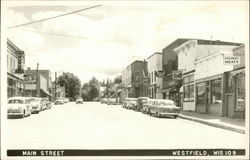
<box><xmin>7</xmin><ymin>102</ymin><xmax>246</xmax><ymax>149</ymax></box>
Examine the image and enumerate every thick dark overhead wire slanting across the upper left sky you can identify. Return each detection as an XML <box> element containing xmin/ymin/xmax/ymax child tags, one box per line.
<box><xmin>8</xmin><ymin>5</ymin><xmax>101</xmax><ymax>29</ymax></box>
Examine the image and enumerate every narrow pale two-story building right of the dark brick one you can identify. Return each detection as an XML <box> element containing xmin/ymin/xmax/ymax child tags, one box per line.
<box><xmin>147</xmin><ymin>52</ymin><xmax>163</xmax><ymax>99</ymax></box>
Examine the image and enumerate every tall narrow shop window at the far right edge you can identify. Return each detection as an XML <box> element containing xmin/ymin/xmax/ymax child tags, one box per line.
<box><xmin>236</xmin><ymin>74</ymin><xmax>245</xmax><ymax>109</ymax></box>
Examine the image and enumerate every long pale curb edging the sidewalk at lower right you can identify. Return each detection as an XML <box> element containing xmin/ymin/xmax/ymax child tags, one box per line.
<box><xmin>178</xmin><ymin>114</ymin><xmax>245</xmax><ymax>134</ymax></box>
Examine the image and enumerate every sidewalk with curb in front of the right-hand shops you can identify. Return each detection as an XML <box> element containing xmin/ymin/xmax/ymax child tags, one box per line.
<box><xmin>178</xmin><ymin>111</ymin><xmax>245</xmax><ymax>134</ymax></box>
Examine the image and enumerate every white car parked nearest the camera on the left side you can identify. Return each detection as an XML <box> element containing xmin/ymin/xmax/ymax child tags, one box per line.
<box><xmin>7</xmin><ymin>97</ymin><xmax>32</xmax><ymax>118</ymax></box>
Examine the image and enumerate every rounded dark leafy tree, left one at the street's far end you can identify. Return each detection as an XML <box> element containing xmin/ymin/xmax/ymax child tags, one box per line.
<box><xmin>58</xmin><ymin>73</ymin><xmax>81</xmax><ymax>100</ymax></box>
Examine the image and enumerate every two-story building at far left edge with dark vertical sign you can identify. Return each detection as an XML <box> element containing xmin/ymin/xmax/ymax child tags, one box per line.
<box><xmin>7</xmin><ymin>39</ymin><xmax>25</xmax><ymax>98</ymax></box>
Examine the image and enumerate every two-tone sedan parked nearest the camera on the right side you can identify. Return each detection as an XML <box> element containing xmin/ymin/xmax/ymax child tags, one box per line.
<box><xmin>148</xmin><ymin>99</ymin><xmax>181</xmax><ymax>118</ymax></box>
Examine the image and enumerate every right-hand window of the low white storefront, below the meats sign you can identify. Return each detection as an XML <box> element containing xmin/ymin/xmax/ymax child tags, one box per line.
<box><xmin>211</xmin><ymin>79</ymin><xmax>222</xmax><ymax>104</ymax></box>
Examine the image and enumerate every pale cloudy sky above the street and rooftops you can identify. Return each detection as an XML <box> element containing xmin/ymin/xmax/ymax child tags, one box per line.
<box><xmin>4</xmin><ymin>1</ymin><xmax>249</xmax><ymax>83</ymax></box>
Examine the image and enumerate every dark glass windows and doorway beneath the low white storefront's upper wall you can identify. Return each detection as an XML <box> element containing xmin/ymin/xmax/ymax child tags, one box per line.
<box><xmin>195</xmin><ymin>74</ymin><xmax>224</xmax><ymax>116</ymax></box>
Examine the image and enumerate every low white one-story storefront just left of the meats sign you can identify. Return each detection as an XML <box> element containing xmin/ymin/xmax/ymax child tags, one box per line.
<box><xmin>195</xmin><ymin>51</ymin><xmax>233</xmax><ymax>116</ymax></box>
